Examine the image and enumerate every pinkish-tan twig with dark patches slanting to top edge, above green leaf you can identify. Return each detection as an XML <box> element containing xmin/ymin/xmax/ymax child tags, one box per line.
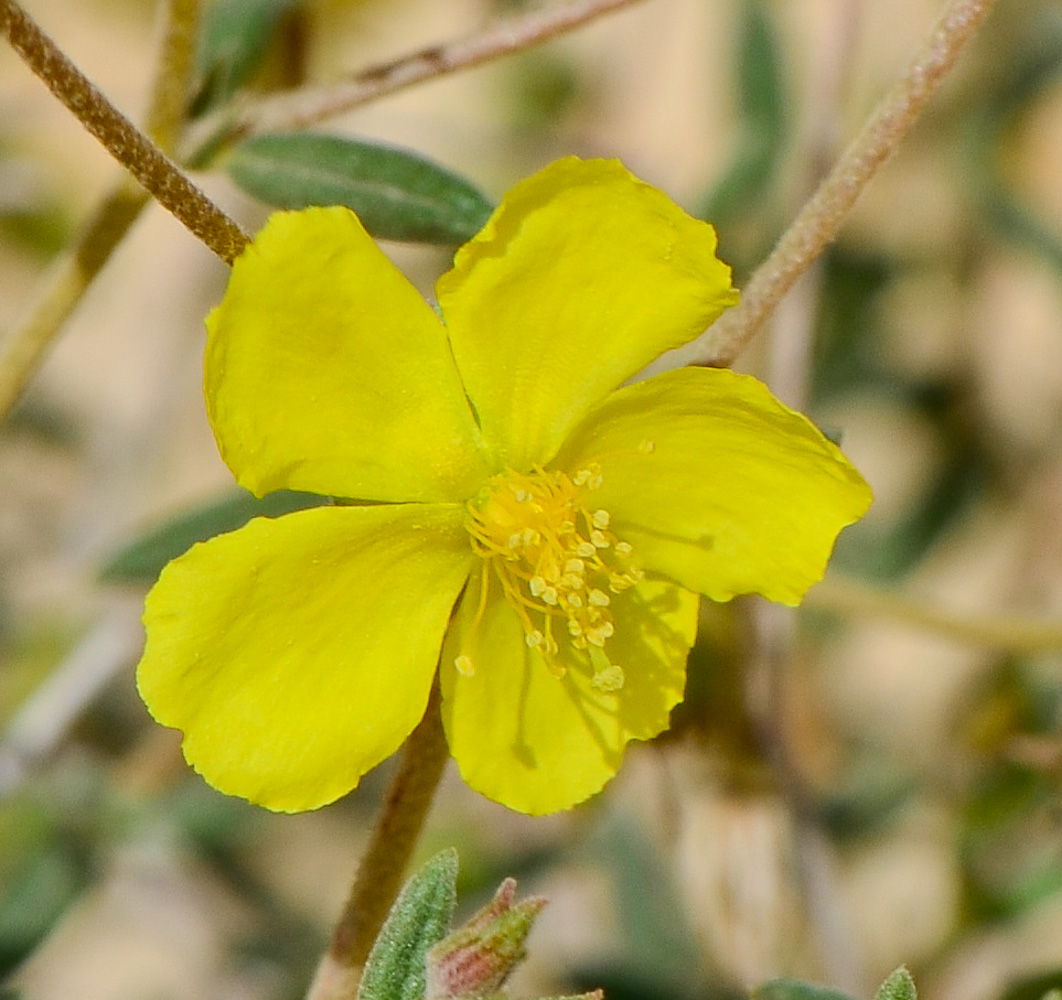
<box><xmin>211</xmin><ymin>0</ymin><xmax>638</xmax><ymax>139</ymax></box>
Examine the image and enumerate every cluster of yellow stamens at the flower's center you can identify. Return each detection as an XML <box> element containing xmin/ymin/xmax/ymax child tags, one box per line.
<box><xmin>456</xmin><ymin>464</ymin><xmax>643</xmax><ymax>690</ymax></box>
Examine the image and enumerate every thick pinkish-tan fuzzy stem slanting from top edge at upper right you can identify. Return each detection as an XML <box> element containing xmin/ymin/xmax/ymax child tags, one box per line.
<box><xmin>691</xmin><ymin>0</ymin><xmax>996</xmax><ymax>367</ymax></box>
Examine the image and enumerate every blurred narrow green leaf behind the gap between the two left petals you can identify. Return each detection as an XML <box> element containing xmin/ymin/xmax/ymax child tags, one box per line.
<box><xmin>100</xmin><ymin>489</ymin><xmax>330</xmax><ymax>584</ymax></box>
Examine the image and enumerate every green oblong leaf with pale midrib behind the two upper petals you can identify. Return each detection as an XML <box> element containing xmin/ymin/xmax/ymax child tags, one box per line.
<box><xmin>225</xmin><ymin>132</ymin><xmax>493</xmax><ymax>243</ymax></box>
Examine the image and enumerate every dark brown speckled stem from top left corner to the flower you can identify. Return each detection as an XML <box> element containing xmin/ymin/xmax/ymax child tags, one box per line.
<box><xmin>0</xmin><ymin>0</ymin><xmax>250</xmax><ymax>263</ymax></box>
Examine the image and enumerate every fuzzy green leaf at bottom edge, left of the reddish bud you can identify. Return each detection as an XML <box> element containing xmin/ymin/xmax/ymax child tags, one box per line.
<box><xmin>358</xmin><ymin>849</ymin><xmax>458</xmax><ymax>1000</ymax></box>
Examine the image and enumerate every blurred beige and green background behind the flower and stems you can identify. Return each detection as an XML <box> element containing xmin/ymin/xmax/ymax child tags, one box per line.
<box><xmin>0</xmin><ymin>0</ymin><xmax>1062</xmax><ymax>1000</ymax></box>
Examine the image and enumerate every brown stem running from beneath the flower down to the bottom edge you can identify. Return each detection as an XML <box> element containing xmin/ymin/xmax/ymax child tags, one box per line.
<box><xmin>308</xmin><ymin>685</ymin><xmax>449</xmax><ymax>1000</ymax></box>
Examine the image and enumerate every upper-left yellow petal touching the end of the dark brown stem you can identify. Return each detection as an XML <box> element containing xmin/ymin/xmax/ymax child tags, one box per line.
<box><xmin>206</xmin><ymin>208</ymin><xmax>484</xmax><ymax>500</ymax></box>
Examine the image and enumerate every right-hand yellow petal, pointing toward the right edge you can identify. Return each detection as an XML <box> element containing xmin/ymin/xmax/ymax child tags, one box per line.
<box><xmin>556</xmin><ymin>368</ymin><xmax>871</xmax><ymax>604</ymax></box>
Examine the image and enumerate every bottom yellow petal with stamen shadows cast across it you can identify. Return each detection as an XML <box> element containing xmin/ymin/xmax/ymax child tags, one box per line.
<box><xmin>440</xmin><ymin>573</ymin><xmax>697</xmax><ymax>815</ymax></box>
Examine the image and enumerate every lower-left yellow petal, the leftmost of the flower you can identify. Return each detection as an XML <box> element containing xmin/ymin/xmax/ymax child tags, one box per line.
<box><xmin>137</xmin><ymin>504</ymin><xmax>475</xmax><ymax>812</ymax></box>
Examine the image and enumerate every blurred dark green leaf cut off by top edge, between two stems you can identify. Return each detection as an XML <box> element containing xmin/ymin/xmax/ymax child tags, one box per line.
<box><xmin>192</xmin><ymin>0</ymin><xmax>302</xmax><ymax>116</ymax></box>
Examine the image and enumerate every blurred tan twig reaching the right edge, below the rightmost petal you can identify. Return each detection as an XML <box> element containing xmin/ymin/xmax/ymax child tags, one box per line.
<box><xmin>804</xmin><ymin>573</ymin><xmax>1062</xmax><ymax>653</ymax></box>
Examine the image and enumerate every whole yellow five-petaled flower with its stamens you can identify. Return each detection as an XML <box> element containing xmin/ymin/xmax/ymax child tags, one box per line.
<box><xmin>138</xmin><ymin>158</ymin><xmax>870</xmax><ymax>813</ymax></box>
